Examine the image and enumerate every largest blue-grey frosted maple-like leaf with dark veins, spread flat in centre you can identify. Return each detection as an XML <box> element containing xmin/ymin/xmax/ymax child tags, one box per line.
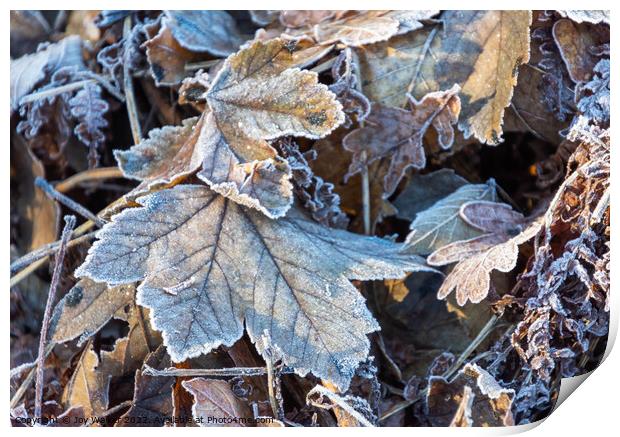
<box><xmin>76</xmin><ymin>185</ymin><xmax>429</xmax><ymax>389</ymax></box>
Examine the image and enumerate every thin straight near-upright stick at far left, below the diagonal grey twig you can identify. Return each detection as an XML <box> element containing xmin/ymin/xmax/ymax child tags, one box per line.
<box><xmin>34</xmin><ymin>215</ymin><xmax>75</xmax><ymax>418</ymax></box>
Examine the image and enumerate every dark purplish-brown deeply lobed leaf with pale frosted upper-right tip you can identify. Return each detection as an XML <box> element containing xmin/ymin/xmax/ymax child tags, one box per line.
<box><xmin>342</xmin><ymin>85</ymin><xmax>461</xmax><ymax>197</ymax></box>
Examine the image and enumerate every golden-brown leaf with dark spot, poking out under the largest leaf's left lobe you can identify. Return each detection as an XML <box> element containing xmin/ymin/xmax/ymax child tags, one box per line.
<box><xmin>50</xmin><ymin>278</ymin><xmax>135</xmax><ymax>344</ymax></box>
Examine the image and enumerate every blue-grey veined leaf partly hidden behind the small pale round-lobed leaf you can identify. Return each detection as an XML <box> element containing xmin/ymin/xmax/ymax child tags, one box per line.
<box><xmin>405</xmin><ymin>181</ymin><xmax>496</xmax><ymax>255</ymax></box>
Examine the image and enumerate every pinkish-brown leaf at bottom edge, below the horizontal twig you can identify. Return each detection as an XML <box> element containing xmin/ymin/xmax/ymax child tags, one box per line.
<box><xmin>181</xmin><ymin>378</ymin><xmax>253</xmax><ymax>426</ymax></box>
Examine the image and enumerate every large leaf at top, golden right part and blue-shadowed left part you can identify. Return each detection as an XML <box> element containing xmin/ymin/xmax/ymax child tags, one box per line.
<box><xmin>358</xmin><ymin>11</ymin><xmax>531</xmax><ymax>145</ymax></box>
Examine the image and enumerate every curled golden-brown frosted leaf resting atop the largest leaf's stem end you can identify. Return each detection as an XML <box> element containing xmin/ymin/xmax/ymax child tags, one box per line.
<box><xmin>199</xmin><ymin>39</ymin><xmax>344</xmax><ymax>218</ymax></box>
